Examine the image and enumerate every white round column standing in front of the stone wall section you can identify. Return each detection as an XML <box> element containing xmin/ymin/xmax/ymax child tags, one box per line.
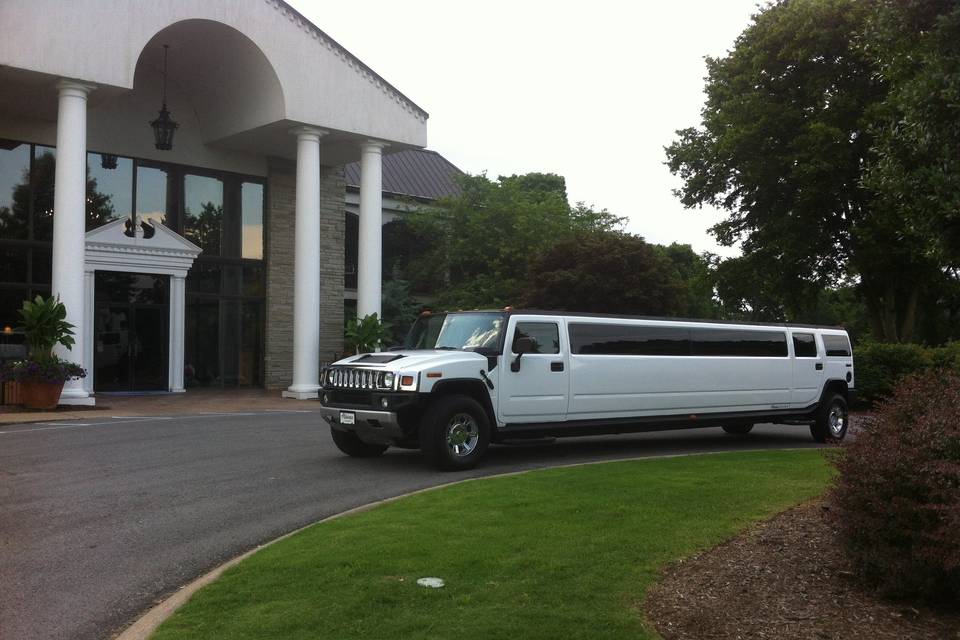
<box><xmin>283</xmin><ymin>127</ymin><xmax>326</xmax><ymax>400</ymax></box>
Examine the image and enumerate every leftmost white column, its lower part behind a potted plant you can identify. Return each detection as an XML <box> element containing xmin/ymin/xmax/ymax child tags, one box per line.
<box><xmin>51</xmin><ymin>80</ymin><xmax>94</xmax><ymax>405</ymax></box>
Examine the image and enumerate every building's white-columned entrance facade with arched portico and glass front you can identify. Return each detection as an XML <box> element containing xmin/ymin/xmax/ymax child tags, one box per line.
<box><xmin>0</xmin><ymin>0</ymin><xmax>427</xmax><ymax>404</ymax></box>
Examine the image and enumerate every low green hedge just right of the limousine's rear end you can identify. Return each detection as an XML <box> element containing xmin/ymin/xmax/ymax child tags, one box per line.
<box><xmin>853</xmin><ymin>342</ymin><xmax>960</xmax><ymax>406</ymax></box>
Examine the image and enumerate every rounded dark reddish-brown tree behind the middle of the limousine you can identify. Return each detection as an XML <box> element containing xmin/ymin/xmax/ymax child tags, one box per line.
<box><xmin>522</xmin><ymin>231</ymin><xmax>687</xmax><ymax>316</ymax></box>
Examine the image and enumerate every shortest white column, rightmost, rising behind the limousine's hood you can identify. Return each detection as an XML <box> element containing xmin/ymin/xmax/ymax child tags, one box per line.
<box><xmin>357</xmin><ymin>140</ymin><xmax>387</xmax><ymax>318</ymax></box>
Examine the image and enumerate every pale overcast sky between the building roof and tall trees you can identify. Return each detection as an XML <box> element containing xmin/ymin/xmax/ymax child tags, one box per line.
<box><xmin>289</xmin><ymin>0</ymin><xmax>757</xmax><ymax>255</ymax></box>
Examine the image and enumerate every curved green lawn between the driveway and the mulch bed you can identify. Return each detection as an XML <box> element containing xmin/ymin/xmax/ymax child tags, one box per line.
<box><xmin>154</xmin><ymin>450</ymin><xmax>831</xmax><ymax>640</ymax></box>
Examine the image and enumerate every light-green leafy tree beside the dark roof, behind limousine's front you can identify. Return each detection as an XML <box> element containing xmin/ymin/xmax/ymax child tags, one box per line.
<box><xmin>402</xmin><ymin>173</ymin><xmax>622</xmax><ymax>308</ymax></box>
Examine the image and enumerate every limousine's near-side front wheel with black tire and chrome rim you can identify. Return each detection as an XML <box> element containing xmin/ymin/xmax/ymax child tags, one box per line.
<box><xmin>420</xmin><ymin>395</ymin><xmax>490</xmax><ymax>471</ymax></box>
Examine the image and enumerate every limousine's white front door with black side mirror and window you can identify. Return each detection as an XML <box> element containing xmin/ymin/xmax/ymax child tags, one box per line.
<box><xmin>499</xmin><ymin>318</ymin><xmax>570</xmax><ymax>423</ymax></box>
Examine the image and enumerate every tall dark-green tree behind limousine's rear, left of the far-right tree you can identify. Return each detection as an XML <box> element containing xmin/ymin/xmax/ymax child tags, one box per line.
<box><xmin>667</xmin><ymin>0</ymin><xmax>932</xmax><ymax>341</ymax></box>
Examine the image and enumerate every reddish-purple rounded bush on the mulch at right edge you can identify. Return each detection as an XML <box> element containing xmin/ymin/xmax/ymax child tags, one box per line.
<box><xmin>832</xmin><ymin>369</ymin><xmax>960</xmax><ymax>602</ymax></box>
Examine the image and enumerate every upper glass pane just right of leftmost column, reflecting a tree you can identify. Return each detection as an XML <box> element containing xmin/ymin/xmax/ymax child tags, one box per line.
<box><xmin>87</xmin><ymin>153</ymin><xmax>133</xmax><ymax>231</ymax></box>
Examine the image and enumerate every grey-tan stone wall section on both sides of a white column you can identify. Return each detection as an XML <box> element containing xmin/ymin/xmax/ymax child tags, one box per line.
<box><xmin>264</xmin><ymin>160</ymin><xmax>346</xmax><ymax>389</ymax></box>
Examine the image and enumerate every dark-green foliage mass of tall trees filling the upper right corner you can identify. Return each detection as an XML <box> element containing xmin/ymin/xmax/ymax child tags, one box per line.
<box><xmin>667</xmin><ymin>0</ymin><xmax>960</xmax><ymax>341</ymax></box>
